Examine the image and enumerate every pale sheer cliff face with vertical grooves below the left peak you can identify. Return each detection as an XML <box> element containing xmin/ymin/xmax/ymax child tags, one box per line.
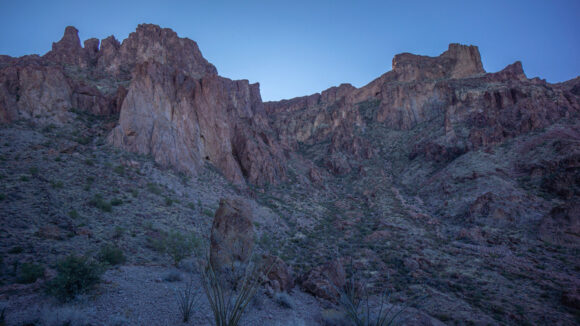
<box><xmin>109</xmin><ymin>62</ymin><xmax>284</xmax><ymax>184</ymax></box>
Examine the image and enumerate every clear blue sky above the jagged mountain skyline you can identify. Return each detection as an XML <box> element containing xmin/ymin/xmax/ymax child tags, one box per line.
<box><xmin>0</xmin><ymin>0</ymin><xmax>580</xmax><ymax>100</ymax></box>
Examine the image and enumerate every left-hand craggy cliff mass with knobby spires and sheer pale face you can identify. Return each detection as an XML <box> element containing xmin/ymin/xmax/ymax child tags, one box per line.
<box><xmin>0</xmin><ymin>25</ymin><xmax>285</xmax><ymax>184</ymax></box>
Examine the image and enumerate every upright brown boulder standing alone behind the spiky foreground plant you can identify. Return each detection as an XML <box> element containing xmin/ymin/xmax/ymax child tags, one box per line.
<box><xmin>209</xmin><ymin>198</ymin><xmax>254</xmax><ymax>271</ymax></box>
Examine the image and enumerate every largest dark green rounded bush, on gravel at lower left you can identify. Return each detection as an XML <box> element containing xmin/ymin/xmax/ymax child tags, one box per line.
<box><xmin>47</xmin><ymin>255</ymin><xmax>103</xmax><ymax>301</ymax></box>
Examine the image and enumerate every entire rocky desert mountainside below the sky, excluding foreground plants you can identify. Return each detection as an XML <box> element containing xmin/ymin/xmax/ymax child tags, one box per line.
<box><xmin>0</xmin><ymin>24</ymin><xmax>580</xmax><ymax>325</ymax></box>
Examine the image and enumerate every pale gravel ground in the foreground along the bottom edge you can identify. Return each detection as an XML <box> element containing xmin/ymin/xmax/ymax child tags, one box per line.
<box><xmin>5</xmin><ymin>266</ymin><xmax>321</xmax><ymax>326</ymax></box>
